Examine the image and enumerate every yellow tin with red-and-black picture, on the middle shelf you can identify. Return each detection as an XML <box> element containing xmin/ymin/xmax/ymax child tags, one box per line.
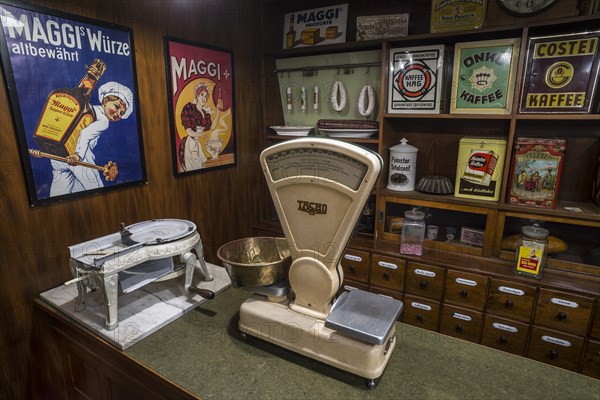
<box><xmin>454</xmin><ymin>137</ymin><xmax>506</xmax><ymax>201</ymax></box>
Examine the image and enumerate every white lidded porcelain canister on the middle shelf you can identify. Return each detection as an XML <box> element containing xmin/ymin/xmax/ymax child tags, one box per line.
<box><xmin>387</xmin><ymin>139</ymin><xmax>419</xmax><ymax>191</ymax></box>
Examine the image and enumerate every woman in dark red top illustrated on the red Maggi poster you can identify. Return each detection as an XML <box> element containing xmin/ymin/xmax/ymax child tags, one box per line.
<box><xmin>178</xmin><ymin>82</ymin><xmax>220</xmax><ymax>171</ymax></box>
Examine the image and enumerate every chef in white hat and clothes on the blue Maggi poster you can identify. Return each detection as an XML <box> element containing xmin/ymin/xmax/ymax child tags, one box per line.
<box><xmin>29</xmin><ymin>82</ymin><xmax>133</xmax><ymax>196</ymax></box>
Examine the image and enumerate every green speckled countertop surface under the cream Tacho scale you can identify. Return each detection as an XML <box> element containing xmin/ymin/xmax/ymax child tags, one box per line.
<box><xmin>126</xmin><ymin>289</ymin><xmax>600</xmax><ymax>400</ymax></box>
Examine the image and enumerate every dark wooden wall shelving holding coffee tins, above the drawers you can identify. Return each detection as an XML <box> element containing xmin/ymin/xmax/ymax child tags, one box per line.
<box><xmin>263</xmin><ymin>16</ymin><xmax>600</xmax><ymax>279</ymax></box>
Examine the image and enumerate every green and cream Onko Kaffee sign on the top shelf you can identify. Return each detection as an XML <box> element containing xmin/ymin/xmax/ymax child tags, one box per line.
<box><xmin>450</xmin><ymin>38</ymin><xmax>521</xmax><ymax>114</ymax></box>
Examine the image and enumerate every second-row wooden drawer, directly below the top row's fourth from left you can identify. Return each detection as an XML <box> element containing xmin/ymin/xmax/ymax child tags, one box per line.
<box><xmin>440</xmin><ymin>304</ymin><xmax>483</xmax><ymax>343</ymax></box>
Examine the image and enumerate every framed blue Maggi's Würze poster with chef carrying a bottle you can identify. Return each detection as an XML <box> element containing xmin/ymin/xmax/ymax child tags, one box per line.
<box><xmin>0</xmin><ymin>0</ymin><xmax>147</xmax><ymax>206</ymax></box>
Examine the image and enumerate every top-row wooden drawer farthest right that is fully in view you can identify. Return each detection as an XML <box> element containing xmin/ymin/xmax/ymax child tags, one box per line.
<box><xmin>535</xmin><ymin>289</ymin><xmax>593</xmax><ymax>336</ymax></box>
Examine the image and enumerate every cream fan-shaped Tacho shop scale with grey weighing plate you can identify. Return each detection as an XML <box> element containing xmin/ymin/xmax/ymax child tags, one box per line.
<box><xmin>239</xmin><ymin>138</ymin><xmax>403</xmax><ymax>388</ymax></box>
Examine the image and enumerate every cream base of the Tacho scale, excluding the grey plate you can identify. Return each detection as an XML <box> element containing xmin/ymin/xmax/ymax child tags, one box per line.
<box><xmin>238</xmin><ymin>295</ymin><xmax>396</xmax><ymax>387</ymax></box>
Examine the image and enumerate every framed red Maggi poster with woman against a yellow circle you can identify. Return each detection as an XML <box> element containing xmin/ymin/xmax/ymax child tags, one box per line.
<box><xmin>164</xmin><ymin>36</ymin><xmax>236</xmax><ymax>176</ymax></box>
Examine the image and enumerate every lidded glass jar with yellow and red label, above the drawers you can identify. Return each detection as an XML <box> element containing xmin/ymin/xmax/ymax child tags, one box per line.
<box><xmin>515</xmin><ymin>225</ymin><xmax>550</xmax><ymax>279</ymax></box>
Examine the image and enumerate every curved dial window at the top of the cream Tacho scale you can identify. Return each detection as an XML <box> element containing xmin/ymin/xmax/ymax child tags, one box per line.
<box><xmin>266</xmin><ymin>148</ymin><xmax>368</xmax><ymax>191</ymax></box>
